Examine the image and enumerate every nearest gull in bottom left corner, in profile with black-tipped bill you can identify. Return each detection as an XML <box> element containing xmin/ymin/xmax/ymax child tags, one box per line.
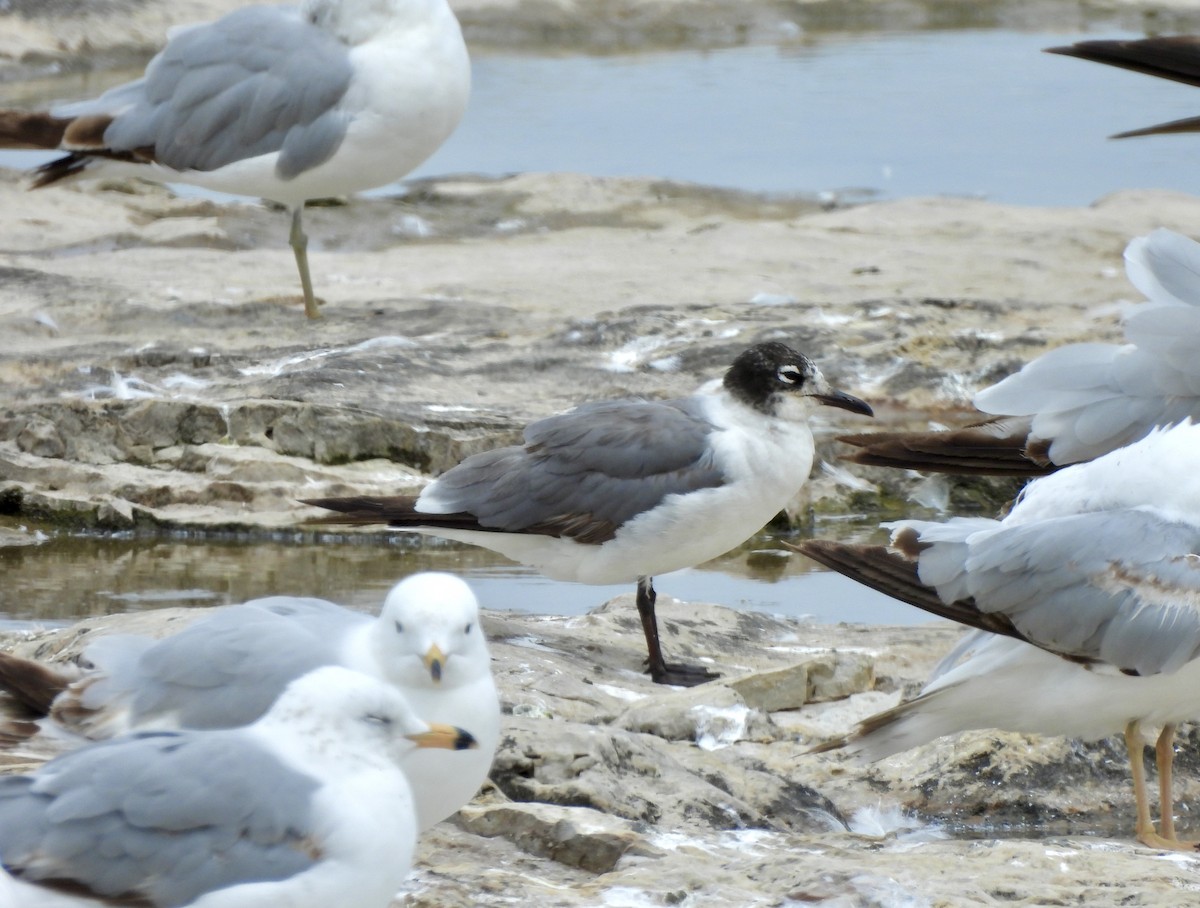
<box><xmin>0</xmin><ymin>666</ymin><xmax>472</xmax><ymax>908</ymax></box>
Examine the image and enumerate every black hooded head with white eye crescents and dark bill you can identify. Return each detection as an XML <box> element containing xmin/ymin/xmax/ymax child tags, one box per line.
<box><xmin>725</xmin><ymin>341</ymin><xmax>875</xmax><ymax>419</ymax></box>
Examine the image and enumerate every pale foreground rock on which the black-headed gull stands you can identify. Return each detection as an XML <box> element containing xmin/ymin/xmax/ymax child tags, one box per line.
<box><xmin>0</xmin><ymin>596</ymin><xmax>1200</xmax><ymax>908</ymax></box>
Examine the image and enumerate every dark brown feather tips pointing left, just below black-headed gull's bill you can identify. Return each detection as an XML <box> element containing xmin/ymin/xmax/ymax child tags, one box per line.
<box><xmin>838</xmin><ymin>417</ymin><xmax>1057</xmax><ymax>477</ymax></box>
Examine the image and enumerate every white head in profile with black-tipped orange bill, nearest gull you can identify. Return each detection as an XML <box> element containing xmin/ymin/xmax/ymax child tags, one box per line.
<box><xmin>260</xmin><ymin>666</ymin><xmax>476</xmax><ymax>760</ymax></box>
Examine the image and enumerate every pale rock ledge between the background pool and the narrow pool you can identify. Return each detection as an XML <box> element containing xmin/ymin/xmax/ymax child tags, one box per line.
<box><xmin>7</xmin><ymin>173</ymin><xmax>1200</xmax><ymax>531</ymax></box>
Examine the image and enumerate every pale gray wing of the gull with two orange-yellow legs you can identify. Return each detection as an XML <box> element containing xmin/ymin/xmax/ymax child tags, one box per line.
<box><xmin>914</xmin><ymin>509</ymin><xmax>1200</xmax><ymax>675</ymax></box>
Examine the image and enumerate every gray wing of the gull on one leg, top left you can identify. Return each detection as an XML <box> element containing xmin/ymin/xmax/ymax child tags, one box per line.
<box><xmin>99</xmin><ymin>6</ymin><xmax>353</xmax><ymax>180</ymax></box>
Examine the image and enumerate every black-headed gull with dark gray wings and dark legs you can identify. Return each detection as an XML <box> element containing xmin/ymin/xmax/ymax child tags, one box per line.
<box><xmin>306</xmin><ymin>342</ymin><xmax>871</xmax><ymax>685</ymax></box>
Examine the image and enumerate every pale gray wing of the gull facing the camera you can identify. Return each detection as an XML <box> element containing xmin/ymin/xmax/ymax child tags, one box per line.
<box><xmin>82</xmin><ymin>596</ymin><xmax>360</xmax><ymax>728</ymax></box>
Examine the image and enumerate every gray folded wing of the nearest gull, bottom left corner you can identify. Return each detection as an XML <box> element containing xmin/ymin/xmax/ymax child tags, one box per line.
<box><xmin>0</xmin><ymin>733</ymin><xmax>318</xmax><ymax>908</ymax></box>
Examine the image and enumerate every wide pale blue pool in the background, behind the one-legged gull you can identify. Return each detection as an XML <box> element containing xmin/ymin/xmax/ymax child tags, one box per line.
<box><xmin>0</xmin><ymin>30</ymin><xmax>1200</xmax><ymax>205</ymax></box>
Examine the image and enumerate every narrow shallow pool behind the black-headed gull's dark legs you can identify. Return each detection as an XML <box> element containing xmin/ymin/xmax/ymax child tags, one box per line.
<box><xmin>0</xmin><ymin>520</ymin><xmax>929</xmax><ymax>627</ymax></box>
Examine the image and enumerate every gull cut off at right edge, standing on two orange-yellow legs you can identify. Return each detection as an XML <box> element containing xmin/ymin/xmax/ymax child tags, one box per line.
<box><xmin>794</xmin><ymin>421</ymin><xmax>1200</xmax><ymax>850</ymax></box>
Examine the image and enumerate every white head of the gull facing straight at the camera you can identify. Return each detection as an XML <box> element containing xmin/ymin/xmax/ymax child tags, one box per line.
<box><xmin>374</xmin><ymin>572</ymin><xmax>491</xmax><ymax>687</ymax></box>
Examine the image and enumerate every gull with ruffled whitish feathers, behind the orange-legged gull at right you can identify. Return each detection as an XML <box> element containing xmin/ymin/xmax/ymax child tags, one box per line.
<box><xmin>840</xmin><ymin>228</ymin><xmax>1200</xmax><ymax>476</ymax></box>
